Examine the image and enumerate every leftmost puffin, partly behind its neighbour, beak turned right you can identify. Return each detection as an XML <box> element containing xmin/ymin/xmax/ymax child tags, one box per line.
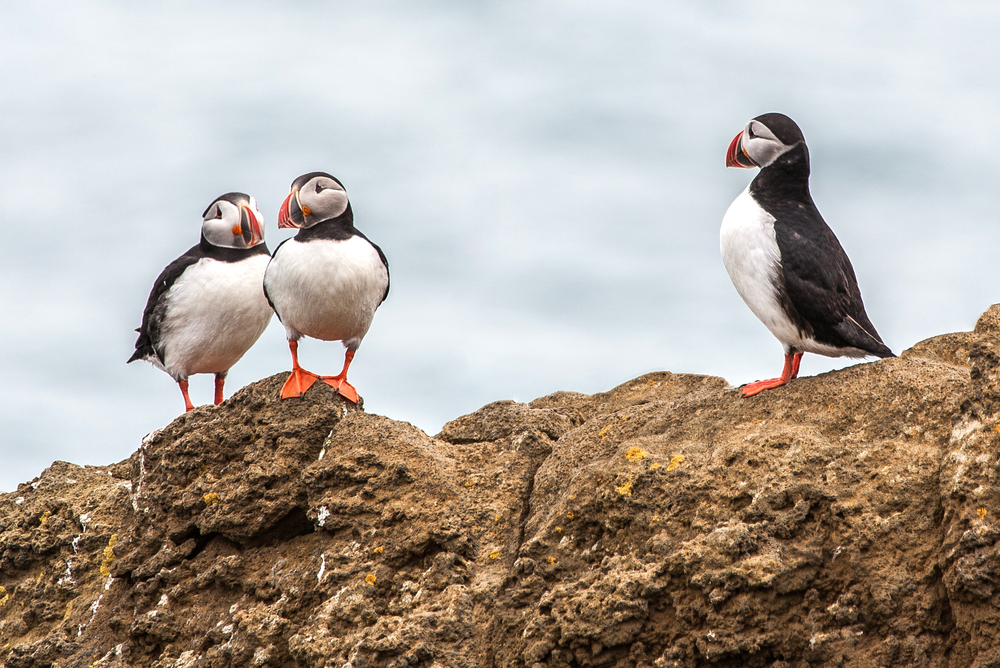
<box><xmin>128</xmin><ymin>193</ymin><xmax>273</xmax><ymax>411</ymax></box>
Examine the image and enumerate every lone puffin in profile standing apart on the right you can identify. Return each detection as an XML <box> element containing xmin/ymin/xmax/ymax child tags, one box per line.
<box><xmin>720</xmin><ymin>113</ymin><xmax>895</xmax><ymax>397</ymax></box>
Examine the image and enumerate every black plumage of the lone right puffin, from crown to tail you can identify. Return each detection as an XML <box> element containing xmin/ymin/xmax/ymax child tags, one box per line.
<box><xmin>750</xmin><ymin>143</ymin><xmax>894</xmax><ymax>357</ymax></box>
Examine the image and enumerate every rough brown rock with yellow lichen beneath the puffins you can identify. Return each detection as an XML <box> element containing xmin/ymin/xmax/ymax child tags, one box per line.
<box><xmin>0</xmin><ymin>306</ymin><xmax>1000</xmax><ymax>668</ymax></box>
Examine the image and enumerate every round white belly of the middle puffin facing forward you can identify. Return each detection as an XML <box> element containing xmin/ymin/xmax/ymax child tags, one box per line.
<box><xmin>264</xmin><ymin>236</ymin><xmax>389</xmax><ymax>347</ymax></box>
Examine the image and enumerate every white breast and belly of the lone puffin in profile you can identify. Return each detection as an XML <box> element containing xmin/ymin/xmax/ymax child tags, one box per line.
<box><xmin>720</xmin><ymin>187</ymin><xmax>802</xmax><ymax>346</ymax></box>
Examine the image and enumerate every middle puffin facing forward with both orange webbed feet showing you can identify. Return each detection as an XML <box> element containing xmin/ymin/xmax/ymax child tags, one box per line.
<box><xmin>264</xmin><ymin>172</ymin><xmax>389</xmax><ymax>403</ymax></box>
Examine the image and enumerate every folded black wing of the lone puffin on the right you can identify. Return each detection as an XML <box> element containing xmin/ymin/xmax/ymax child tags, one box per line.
<box><xmin>768</xmin><ymin>202</ymin><xmax>894</xmax><ymax>357</ymax></box>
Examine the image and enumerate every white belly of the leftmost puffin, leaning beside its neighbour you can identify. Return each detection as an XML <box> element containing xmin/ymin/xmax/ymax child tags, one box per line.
<box><xmin>160</xmin><ymin>255</ymin><xmax>273</xmax><ymax>378</ymax></box>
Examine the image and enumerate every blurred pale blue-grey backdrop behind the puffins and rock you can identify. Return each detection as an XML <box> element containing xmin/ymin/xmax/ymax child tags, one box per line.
<box><xmin>0</xmin><ymin>0</ymin><xmax>1000</xmax><ymax>490</ymax></box>
